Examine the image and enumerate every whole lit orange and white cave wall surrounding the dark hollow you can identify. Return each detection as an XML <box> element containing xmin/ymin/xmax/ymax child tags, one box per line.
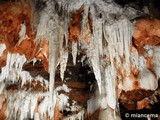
<box><xmin>0</xmin><ymin>0</ymin><xmax>160</xmax><ymax>120</ymax></box>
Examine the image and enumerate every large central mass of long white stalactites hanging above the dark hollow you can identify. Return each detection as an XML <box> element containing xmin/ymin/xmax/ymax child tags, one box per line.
<box><xmin>33</xmin><ymin>0</ymin><xmax>157</xmax><ymax>117</ymax></box>
